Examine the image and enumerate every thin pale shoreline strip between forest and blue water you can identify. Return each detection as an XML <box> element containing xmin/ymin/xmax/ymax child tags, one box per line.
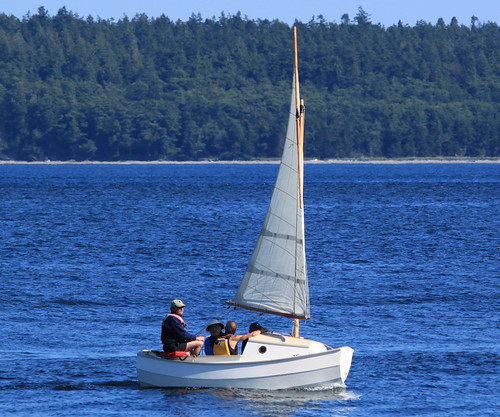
<box><xmin>0</xmin><ymin>158</ymin><xmax>500</xmax><ymax>165</ymax></box>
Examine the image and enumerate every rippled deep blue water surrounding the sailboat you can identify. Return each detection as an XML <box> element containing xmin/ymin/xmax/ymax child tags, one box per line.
<box><xmin>0</xmin><ymin>164</ymin><xmax>500</xmax><ymax>416</ymax></box>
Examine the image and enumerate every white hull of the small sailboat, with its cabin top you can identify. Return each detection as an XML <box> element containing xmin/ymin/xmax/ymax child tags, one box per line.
<box><xmin>137</xmin><ymin>336</ymin><xmax>353</xmax><ymax>390</ymax></box>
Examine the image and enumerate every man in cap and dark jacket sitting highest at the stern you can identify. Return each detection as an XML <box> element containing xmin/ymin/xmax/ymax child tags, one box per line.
<box><xmin>161</xmin><ymin>300</ymin><xmax>205</xmax><ymax>356</ymax></box>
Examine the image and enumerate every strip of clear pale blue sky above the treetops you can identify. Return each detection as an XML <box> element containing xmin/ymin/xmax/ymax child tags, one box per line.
<box><xmin>0</xmin><ymin>0</ymin><xmax>500</xmax><ymax>27</ymax></box>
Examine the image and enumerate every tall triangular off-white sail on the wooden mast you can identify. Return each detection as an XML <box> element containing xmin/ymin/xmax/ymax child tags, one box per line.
<box><xmin>229</xmin><ymin>76</ymin><xmax>310</xmax><ymax>319</ymax></box>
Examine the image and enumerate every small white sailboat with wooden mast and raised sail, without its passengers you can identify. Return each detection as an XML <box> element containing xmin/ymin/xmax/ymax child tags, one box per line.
<box><xmin>137</xmin><ymin>28</ymin><xmax>353</xmax><ymax>390</ymax></box>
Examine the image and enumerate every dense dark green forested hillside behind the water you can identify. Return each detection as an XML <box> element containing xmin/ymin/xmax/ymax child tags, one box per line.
<box><xmin>0</xmin><ymin>7</ymin><xmax>500</xmax><ymax>161</ymax></box>
